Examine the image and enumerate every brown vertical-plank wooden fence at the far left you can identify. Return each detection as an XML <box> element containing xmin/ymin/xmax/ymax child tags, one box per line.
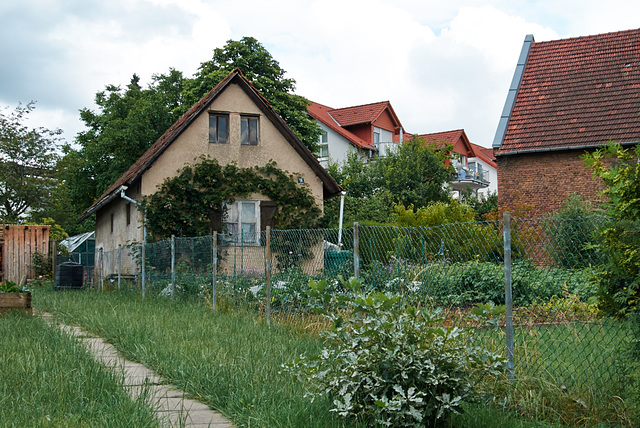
<box><xmin>0</xmin><ymin>224</ymin><xmax>50</xmax><ymax>284</ymax></box>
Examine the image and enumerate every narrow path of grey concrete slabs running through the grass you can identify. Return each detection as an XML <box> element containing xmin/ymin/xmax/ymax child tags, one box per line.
<box><xmin>40</xmin><ymin>313</ymin><xmax>233</xmax><ymax>428</ymax></box>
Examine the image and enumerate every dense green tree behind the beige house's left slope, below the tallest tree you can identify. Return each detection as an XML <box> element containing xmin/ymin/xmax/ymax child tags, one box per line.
<box><xmin>65</xmin><ymin>70</ymin><xmax>184</xmax><ymax>208</ymax></box>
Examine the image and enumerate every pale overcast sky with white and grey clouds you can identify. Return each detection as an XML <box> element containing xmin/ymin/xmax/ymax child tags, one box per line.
<box><xmin>0</xmin><ymin>0</ymin><xmax>640</xmax><ymax>147</ymax></box>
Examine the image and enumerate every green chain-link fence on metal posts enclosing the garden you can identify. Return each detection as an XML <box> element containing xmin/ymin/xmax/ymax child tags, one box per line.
<box><xmin>96</xmin><ymin>218</ymin><xmax>629</xmax><ymax>388</ymax></box>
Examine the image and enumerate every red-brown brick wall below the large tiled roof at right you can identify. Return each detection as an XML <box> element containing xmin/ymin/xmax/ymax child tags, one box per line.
<box><xmin>497</xmin><ymin>151</ymin><xmax>604</xmax><ymax>218</ymax></box>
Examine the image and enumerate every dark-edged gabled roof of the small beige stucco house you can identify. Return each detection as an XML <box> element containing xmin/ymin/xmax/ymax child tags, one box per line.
<box><xmin>79</xmin><ymin>69</ymin><xmax>342</xmax><ymax>221</ymax></box>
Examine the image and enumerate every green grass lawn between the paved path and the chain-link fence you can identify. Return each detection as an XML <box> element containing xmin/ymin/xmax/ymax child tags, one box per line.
<box><xmin>34</xmin><ymin>288</ymin><xmax>564</xmax><ymax>427</ymax></box>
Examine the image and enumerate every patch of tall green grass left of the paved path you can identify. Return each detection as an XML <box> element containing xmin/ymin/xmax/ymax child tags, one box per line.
<box><xmin>0</xmin><ymin>313</ymin><xmax>158</xmax><ymax>427</ymax></box>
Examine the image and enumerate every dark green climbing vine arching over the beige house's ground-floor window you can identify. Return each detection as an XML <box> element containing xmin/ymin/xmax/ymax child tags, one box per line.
<box><xmin>143</xmin><ymin>156</ymin><xmax>321</xmax><ymax>239</ymax></box>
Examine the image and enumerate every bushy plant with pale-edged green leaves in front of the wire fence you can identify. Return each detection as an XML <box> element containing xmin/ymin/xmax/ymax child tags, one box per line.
<box><xmin>284</xmin><ymin>279</ymin><xmax>504</xmax><ymax>427</ymax></box>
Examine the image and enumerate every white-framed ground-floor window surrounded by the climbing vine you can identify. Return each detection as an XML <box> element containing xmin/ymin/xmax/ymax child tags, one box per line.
<box><xmin>224</xmin><ymin>199</ymin><xmax>261</xmax><ymax>245</ymax></box>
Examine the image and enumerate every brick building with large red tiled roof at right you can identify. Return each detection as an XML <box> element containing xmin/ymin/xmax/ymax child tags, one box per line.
<box><xmin>493</xmin><ymin>29</ymin><xmax>640</xmax><ymax>217</ymax></box>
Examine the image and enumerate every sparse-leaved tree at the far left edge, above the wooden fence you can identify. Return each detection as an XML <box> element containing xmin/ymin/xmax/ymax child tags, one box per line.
<box><xmin>0</xmin><ymin>102</ymin><xmax>62</xmax><ymax>223</ymax></box>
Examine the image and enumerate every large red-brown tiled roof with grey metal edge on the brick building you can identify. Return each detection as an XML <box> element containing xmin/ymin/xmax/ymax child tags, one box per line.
<box><xmin>494</xmin><ymin>29</ymin><xmax>640</xmax><ymax>155</ymax></box>
